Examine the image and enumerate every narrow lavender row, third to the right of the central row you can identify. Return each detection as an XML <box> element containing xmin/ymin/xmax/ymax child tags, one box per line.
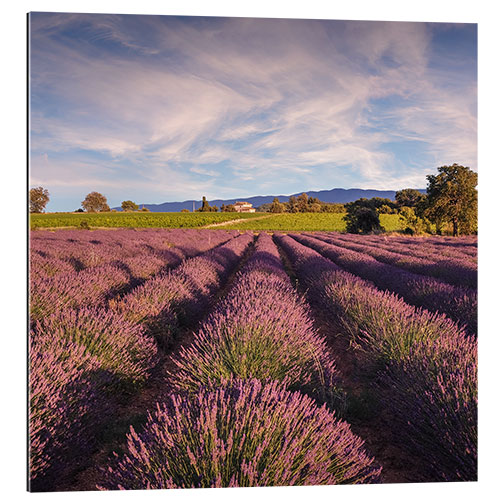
<box><xmin>324</xmin><ymin>233</ymin><xmax>477</xmax><ymax>288</ymax></box>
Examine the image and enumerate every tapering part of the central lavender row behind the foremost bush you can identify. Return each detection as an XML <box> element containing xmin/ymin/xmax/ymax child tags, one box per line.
<box><xmin>172</xmin><ymin>233</ymin><xmax>342</xmax><ymax>407</ymax></box>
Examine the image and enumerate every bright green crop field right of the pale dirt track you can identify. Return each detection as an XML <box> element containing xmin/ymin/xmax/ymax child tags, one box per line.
<box><xmin>231</xmin><ymin>213</ymin><xmax>401</xmax><ymax>232</ymax></box>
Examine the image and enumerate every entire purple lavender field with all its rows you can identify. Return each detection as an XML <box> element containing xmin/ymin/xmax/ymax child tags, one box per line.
<box><xmin>29</xmin><ymin>226</ymin><xmax>477</xmax><ymax>491</ymax></box>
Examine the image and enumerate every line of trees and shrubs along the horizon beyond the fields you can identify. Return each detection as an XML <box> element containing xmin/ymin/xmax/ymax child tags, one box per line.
<box><xmin>29</xmin><ymin>163</ymin><xmax>478</xmax><ymax>236</ymax></box>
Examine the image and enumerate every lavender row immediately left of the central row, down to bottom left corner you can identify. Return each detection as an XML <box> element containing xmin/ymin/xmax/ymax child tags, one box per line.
<box><xmin>30</xmin><ymin>234</ymin><xmax>252</xmax><ymax>490</ymax></box>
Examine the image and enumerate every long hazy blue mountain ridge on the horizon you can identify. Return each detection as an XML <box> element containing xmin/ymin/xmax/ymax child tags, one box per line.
<box><xmin>115</xmin><ymin>188</ymin><xmax>426</xmax><ymax>212</ymax></box>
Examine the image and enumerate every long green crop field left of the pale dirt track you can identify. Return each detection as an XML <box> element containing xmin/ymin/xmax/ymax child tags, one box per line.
<box><xmin>30</xmin><ymin>212</ymin><xmax>263</xmax><ymax>229</ymax></box>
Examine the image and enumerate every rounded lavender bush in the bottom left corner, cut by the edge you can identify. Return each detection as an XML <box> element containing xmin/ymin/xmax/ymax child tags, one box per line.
<box><xmin>29</xmin><ymin>335</ymin><xmax>109</xmax><ymax>490</ymax></box>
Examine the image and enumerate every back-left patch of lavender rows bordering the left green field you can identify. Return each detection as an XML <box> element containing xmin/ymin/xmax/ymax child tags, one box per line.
<box><xmin>30</xmin><ymin>229</ymin><xmax>238</xmax><ymax>321</ymax></box>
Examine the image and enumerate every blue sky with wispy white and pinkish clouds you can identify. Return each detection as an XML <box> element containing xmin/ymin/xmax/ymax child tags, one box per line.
<box><xmin>30</xmin><ymin>13</ymin><xmax>477</xmax><ymax>211</ymax></box>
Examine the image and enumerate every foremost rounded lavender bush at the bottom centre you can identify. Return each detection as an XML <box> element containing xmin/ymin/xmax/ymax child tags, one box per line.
<box><xmin>100</xmin><ymin>379</ymin><xmax>380</xmax><ymax>489</ymax></box>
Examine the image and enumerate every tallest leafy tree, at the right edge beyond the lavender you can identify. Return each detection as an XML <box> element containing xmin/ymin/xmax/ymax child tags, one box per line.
<box><xmin>426</xmin><ymin>163</ymin><xmax>477</xmax><ymax>236</ymax></box>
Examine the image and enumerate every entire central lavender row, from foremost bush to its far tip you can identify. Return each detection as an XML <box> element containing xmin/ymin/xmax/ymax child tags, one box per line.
<box><xmin>100</xmin><ymin>233</ymin><xmax>380</xmax><ymax>489</ymax></box>
